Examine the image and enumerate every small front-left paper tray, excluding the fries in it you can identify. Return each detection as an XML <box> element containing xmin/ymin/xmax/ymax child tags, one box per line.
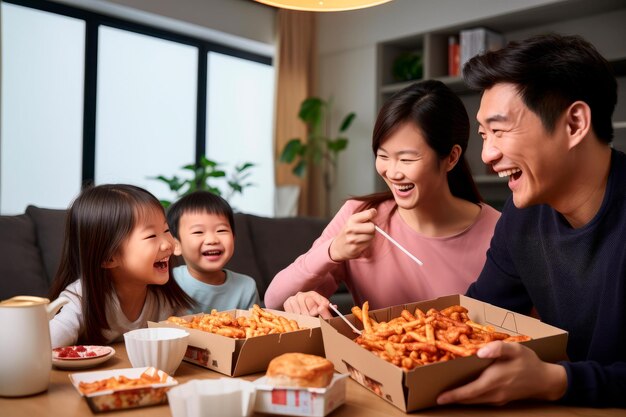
<box><xmin>68</xmin><ymin>367</ymin><xmax>178</xmax><ymax>413</ymax></box>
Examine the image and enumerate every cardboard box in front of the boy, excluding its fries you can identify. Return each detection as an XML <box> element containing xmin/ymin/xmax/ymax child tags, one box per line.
<box><xmin>148</xmin><ymin>309</ymin><xmax>324</xmax><ymax>376</ymax></box>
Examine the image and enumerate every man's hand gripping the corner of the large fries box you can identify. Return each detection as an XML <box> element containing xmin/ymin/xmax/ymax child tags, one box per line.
<box><xmin>437</xmin><ymin>341</ymin><xmax>567</xmax><ymax>405</ymax></box>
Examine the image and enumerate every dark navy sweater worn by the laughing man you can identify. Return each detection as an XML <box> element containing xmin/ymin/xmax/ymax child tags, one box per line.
<box><xmin>467</xmin><ymin>150</ymin><xmax>626</xmax><ymax>407</ymax></box>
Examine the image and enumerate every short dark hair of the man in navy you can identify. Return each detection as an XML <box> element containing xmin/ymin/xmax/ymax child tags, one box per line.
<box><xmin>463</xmin><ymin>33</ymin><xmax>617</xmax><ymax>143</ymax></box>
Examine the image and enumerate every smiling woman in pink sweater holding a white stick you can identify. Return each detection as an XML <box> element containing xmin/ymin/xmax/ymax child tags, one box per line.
<box><xmin>264</xmin><ymin>81</ymin><xmax>500</xmax><ymax>318</ymax></box>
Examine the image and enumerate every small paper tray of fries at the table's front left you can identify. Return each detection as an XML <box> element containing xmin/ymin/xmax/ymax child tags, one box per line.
<box><xmin>69</xmin><ymin>367</ymin><xmax>178</xmax><ymax>413</ymax></box>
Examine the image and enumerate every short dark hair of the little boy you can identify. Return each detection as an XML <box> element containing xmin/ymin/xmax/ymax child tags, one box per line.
<box><xmin>167</xmin><ymin>191</ymin><xmax>235</xmax><ymax>239</ymax></box>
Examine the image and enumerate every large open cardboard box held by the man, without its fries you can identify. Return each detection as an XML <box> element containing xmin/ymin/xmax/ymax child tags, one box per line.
<box><xmin>319</xmin><ymin>295</ymin><xmax>567</xmax><ymax>412</ymax></box>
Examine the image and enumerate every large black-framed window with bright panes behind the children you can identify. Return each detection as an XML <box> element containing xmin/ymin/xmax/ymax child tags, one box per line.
<box><xmin>0</xmin><ymin>0</ymin><xmax>274</xmax><ymax>216</ymax></box>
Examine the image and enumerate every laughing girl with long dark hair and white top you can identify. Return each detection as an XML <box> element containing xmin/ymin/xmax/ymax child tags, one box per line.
<box><xmin>50</xmin><ymin>184</ymin><xmax>191</xmax><ymax>347</ymax></box>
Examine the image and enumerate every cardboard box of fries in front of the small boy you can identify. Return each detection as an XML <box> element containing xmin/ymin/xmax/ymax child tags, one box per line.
<box><xmin>148</xmin><ymin>305</ymin><xmax>324</xmax><ymax>376</ymax></box>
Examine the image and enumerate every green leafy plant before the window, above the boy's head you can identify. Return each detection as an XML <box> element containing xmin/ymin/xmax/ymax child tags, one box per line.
<box><xmin>150</xmin><ymin>155</ymin><xmax>254</xmax><ymax>208</ymax></box>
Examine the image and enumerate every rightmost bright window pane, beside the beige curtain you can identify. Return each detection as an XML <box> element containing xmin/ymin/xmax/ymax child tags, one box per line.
<box><xmin>206</xmin><ymin>52</ymin><xmax>275</xmax><ymax>216</ymax></box>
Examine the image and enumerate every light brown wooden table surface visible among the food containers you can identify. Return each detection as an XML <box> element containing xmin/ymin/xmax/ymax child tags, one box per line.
<box><xmin>0</xmin><ymin>344</ymin><xmax>626</xmax><ymax>417</ymax></box>
